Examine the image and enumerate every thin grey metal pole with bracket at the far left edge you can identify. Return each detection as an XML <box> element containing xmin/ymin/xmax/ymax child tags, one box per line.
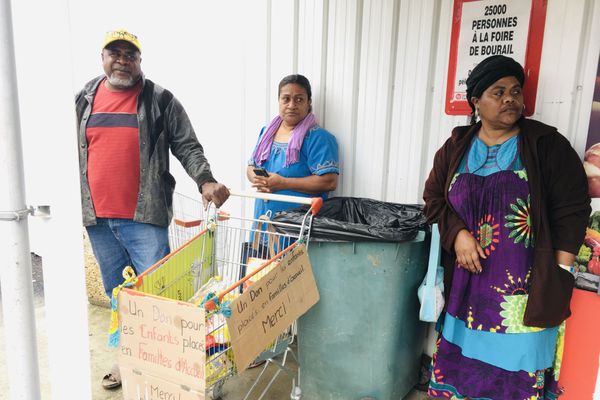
<box><xmin>0</xmin><ymin>0</ymin><xmax>40</xmax><ymax>400</ymax></box>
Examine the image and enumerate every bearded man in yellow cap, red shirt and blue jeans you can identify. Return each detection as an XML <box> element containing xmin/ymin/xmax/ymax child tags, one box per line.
<box><xmin>75</xmin><ymin>29</ymin><xmax>229</xmax><ymax>389</ymax></box>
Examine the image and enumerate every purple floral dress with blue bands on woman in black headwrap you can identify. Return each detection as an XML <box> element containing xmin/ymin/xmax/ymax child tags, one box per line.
<box><xmin>428</xmin><ymin>136</ymin><xmax>564</xmax><ymax>400</ymax></box>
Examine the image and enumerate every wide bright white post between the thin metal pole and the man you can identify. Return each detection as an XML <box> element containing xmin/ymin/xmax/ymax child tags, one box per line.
<box><xmin>6</xmin><ymin>0</ymin><xmax>94</xmax><ymax>400</ymax></box>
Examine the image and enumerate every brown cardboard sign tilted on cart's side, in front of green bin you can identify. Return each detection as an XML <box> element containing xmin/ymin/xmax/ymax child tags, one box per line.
<box><xmin>227</xmin><ymin>245</ymin><xmax>319</xmax><ymax>372</ymax></box>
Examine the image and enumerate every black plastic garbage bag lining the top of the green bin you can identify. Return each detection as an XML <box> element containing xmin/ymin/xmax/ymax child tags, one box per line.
<box><xmin>273</xmin><ymin>197</ymin><xmax>429</xmax><ymax>242</ymax></box>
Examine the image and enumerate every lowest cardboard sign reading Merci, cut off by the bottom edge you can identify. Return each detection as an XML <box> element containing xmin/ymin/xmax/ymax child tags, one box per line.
<box><xmin>120</xmin><ymin>367</ymin><xmax>205</xmax><ymax>400</ymax></box>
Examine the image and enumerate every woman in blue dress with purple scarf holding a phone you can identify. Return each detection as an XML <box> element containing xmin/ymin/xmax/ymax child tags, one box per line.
<box><xmin>246</xmin><ymin>74</ymin><xmax>340</xmax><ymax>218</ymax></box>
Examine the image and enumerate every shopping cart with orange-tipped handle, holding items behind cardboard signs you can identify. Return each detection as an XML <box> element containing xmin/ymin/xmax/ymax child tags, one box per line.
<box><xmin>115</xmin><ymin>192</ymin><xmax>322</xmax><ymax>399</ymax></box>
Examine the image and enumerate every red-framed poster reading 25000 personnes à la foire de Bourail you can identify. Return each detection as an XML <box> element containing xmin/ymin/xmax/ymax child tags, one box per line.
<box><xmin>446</xmin><ymin>0</ymin><xmax>547</xmax><ymax>116</ymax></box>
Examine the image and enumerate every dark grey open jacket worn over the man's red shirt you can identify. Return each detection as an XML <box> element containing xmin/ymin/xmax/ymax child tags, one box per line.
<box><xmin>75</xmin><ymin>76</ymin><xmax>216</xmax><ymax>227</ymax></box>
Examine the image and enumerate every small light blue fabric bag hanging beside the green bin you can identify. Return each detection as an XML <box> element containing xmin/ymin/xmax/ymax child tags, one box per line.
<box><xmin>417</xmin><ymin>224</ymin><xmax>444</xmax><ymax>322</ymax></box>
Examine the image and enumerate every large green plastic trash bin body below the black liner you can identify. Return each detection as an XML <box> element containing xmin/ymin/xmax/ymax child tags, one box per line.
<box><xmin>298</xmin><ymin>231</ymin><xmax>429</xmax><ymax>400</ymax></box>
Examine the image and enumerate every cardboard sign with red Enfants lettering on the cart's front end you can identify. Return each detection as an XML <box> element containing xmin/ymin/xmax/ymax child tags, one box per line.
<box><xmin>119</xmin><ymin>290</ymin><xmax>206</xmax><ymax>392</ymax></box>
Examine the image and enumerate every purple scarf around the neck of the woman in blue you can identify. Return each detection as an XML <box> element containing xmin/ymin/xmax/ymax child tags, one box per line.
<box><xmin>252</xmin><ymin>113</ymin><xmax>317</xmax><ymax>167</ymax></box>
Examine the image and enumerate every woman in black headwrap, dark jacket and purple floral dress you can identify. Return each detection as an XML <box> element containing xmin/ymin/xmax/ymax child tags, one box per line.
<box><xmin>424</xmin><ymin>56</ymin><xmax>590</xmax><ymax>400</ymax></box>
